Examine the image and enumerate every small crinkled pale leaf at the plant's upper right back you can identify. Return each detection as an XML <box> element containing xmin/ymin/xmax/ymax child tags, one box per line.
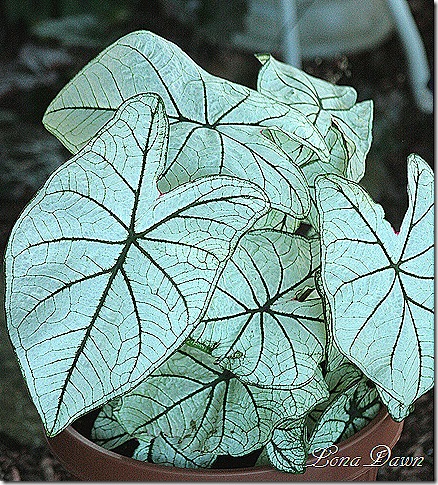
<box><xmin>257</xmin><ymin>56</ymin><xmax>373</xmax><ymax>181</ymax></box>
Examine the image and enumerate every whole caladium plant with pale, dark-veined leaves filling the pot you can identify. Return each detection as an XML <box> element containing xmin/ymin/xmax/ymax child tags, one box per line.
<box><xmin>6</xmin><ymin>32</ymin><xmax>433</xmax><ymax>472</ymax></box>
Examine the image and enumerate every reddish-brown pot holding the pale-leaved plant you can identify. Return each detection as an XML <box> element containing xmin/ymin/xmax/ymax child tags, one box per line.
<box><xmin>47</xmin><ymin>410</ymin><xmax>403</xmax><ymax>482</ymax></box>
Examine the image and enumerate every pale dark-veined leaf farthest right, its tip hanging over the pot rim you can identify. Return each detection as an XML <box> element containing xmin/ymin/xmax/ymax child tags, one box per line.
<box><xmin>316</xmin><ymin>155</ymin><xmax>434</xmax><ymax>419</ymax></box>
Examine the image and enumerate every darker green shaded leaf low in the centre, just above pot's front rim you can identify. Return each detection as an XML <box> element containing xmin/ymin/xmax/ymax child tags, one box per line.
<box><xmin>109</xmin><ymin>346</ymin><xmax>327</xmax><ymax>459</ymax></box>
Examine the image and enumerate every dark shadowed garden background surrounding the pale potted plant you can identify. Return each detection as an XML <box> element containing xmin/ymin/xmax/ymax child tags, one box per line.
<box><xmin>0</xmin><ymin>0</ymin><xmax>434</xmax><ymax>481</ymax></box>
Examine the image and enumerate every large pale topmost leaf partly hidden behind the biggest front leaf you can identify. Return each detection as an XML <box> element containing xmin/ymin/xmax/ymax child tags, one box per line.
<box><xmin>43</xmin><ymin>31</ymin><xmax>326</xmax><ymax>218</ymax></box>
